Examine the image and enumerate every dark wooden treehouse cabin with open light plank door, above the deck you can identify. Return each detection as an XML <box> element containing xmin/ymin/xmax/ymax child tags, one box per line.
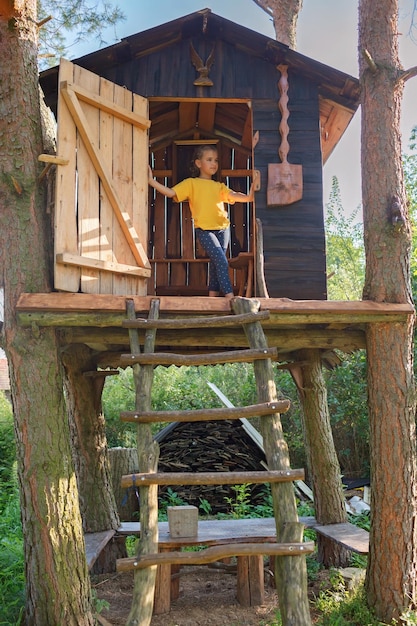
<box><xmin>41</xmin><ymin>9</ymin><xmax>359</xmax><ymax>300</ymax></box>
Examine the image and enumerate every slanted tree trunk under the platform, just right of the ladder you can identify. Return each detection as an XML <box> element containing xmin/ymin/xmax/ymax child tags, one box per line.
<box><xmin>298</xmin><ymin>350</ymin><xmax>350</xmax><ymax>567</ymax></box>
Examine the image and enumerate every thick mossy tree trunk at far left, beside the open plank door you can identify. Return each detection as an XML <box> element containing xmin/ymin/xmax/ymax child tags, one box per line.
<box><xmin>0</xmin><ymin>0</ymin><xmax>94</xmax><ymax>626</ymax></box>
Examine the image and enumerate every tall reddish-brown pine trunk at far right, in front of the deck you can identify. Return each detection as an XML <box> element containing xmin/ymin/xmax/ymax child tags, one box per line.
<box><xmin>359</xmin><ymin>0</ymin><xmax>417</xmax><ymax>622</ymax></box>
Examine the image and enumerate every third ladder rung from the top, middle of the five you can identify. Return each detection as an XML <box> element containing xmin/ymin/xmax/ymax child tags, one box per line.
<box><xmin>120</xmin><ymin>400</ymin><xmax>290</xmax><ymax>424</ymax></box>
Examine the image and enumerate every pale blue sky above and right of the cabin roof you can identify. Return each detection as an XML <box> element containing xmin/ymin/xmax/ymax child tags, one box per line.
<box><xmin>68</xmin><ymin>0</ymin><xmax>417</xmax><ymax>221</ymax></box>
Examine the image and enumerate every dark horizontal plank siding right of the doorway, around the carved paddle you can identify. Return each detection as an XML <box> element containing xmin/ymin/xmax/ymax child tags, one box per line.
<box><xmin>253</xmin><ymin>71</ymin><xmax>327</xmax><ymax>300</ymax></box>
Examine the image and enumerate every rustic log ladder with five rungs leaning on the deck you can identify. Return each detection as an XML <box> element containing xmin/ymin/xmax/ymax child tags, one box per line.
<box><xmin>117</xmin><ymin>298</ymin><xmax>314</xmax><ymax>626</ymax></box>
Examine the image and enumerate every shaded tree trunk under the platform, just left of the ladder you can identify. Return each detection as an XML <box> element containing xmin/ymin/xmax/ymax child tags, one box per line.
<box><xmin>62</xmin><ymin>345</ymin><xmax>120</xmax><ymax>533</ymax></box>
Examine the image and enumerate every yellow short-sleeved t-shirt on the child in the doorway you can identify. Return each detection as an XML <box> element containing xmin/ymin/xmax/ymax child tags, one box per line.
<box><xmin>173</xmin><ymin>178</ymin><xmax>235</xmax><ymax>230</ymax></box>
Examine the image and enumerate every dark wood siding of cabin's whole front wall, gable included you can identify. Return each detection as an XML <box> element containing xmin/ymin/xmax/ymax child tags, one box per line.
<box><xmin>41</xmin><ymin>24</ymin><xmax>334</xmax><ymax>299</ymax></box>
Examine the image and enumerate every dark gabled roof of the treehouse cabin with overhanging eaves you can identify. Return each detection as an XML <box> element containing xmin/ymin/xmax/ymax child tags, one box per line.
<box><xmin>40</xmin><ymin>9</ymin><xmax>360</xmax><ymax>163</ymax></box>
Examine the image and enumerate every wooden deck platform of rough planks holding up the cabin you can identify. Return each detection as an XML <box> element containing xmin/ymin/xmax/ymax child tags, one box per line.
<box><xmin>17</xmin><ymin>292</ymin><xmax>414</xmax><ymax>367</ymax></box>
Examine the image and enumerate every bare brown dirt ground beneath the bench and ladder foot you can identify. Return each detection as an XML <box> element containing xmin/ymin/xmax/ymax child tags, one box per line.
<box><xmin>93</xmin><ymin>566</ymin><xmax>326</xmax><ymax>626</ymax></box>
